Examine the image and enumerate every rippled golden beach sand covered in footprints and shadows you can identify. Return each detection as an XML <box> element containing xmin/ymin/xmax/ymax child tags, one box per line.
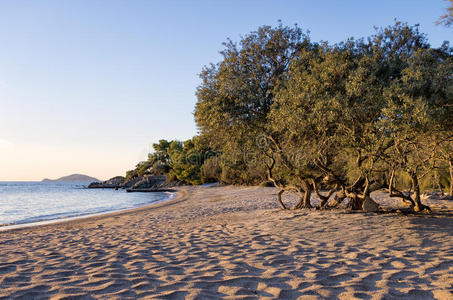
<box><xmin>0</xmin><ymin>186</ymin><xmax>453</xmax><ymax>299</ymax></box>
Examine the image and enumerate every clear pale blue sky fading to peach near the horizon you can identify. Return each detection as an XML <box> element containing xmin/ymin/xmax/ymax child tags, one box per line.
<box><xmin>0</xmin><ymin>0</ymin><xmax>453</xmax><ymax>181</ymax></box>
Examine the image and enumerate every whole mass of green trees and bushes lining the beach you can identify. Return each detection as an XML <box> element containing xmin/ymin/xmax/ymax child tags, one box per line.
<box><xmin>122</xmin><ymin>22</ymin><xmax>453</xmax><ymax>211</ymax></box>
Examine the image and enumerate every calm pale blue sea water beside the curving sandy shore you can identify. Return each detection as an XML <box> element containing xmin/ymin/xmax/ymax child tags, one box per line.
<box><xmin>0</xmin><ymin>182</ymin><xmax>172</xmax><ymax>225</ymax></box>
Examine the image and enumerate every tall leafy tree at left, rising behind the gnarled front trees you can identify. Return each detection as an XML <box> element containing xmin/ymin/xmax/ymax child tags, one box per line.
<box><xmin>195</xmin><ymin>24</ymin><xmax>310</xmax><ymax>183</ymax></box>
